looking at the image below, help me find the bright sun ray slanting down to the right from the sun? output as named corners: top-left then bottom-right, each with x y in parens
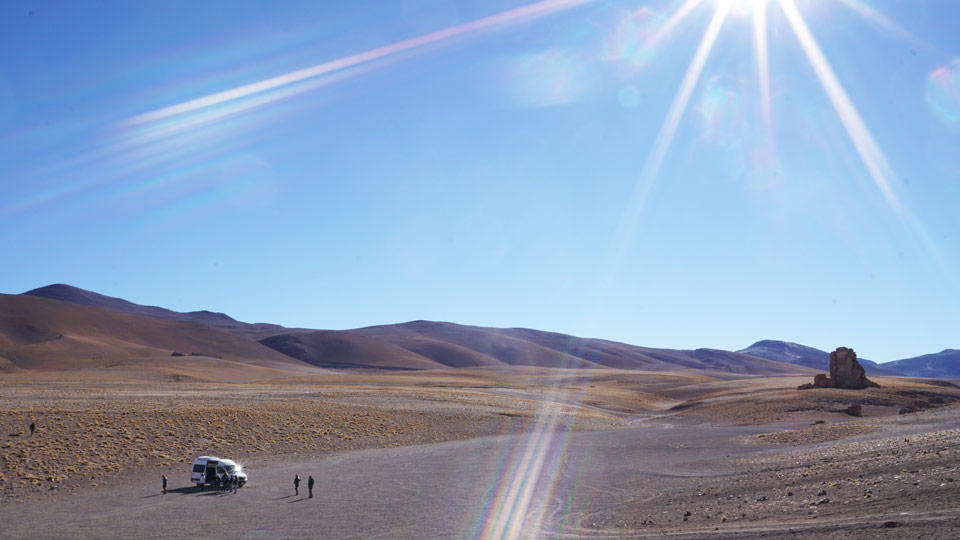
top-left (780, 0), bottom-right (903, 215)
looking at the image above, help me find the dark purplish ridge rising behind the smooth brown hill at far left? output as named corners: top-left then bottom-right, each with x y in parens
top-left (23, 284), bottom-right (299, 340)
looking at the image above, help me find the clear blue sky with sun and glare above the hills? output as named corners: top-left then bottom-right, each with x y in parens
top-left (0, 0), bottom-right (960, 361)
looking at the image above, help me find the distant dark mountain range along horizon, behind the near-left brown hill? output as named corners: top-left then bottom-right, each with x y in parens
top-left (7, 284), bottom-right (960, 378)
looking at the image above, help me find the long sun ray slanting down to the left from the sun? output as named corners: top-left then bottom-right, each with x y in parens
top-left (613, 1), bottom-right (730, 255)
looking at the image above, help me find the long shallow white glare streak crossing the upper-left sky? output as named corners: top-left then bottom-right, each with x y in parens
top-left (126, 0), bottom-right (593, 126)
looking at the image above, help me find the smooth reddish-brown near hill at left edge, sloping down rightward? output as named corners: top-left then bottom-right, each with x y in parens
top-left (0, 294), bottom-right (316, 374)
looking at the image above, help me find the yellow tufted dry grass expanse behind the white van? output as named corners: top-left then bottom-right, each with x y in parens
top-left (0, 380), bottom-right (618, 504)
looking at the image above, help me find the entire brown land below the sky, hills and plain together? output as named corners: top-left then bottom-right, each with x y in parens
top-left (0, 286), bottom-right (960, 539)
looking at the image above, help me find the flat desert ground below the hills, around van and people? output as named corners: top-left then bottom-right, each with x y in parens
top-left (0, 366), bottom-right (960, 539)
